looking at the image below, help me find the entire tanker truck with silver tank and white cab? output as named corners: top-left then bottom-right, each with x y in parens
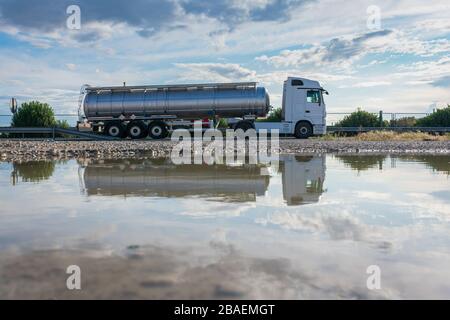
top-left (78, 77), bottom-right (328, 139)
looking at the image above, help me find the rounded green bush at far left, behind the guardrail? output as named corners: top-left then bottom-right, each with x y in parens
top-left (11, 101), bottom-right (57, 128)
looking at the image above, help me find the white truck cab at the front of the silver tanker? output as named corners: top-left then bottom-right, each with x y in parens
top-left (255, 77), bottom-right (328, 139)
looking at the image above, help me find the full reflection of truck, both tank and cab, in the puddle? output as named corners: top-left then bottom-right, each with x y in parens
top-left (80, 155), bottom-right (325, 205)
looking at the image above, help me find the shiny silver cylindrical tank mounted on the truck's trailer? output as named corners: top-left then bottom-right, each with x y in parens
top-left (83, 86), bottom-right (270, 119)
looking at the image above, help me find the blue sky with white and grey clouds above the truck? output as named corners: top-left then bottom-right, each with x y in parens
top-left (0, 0), bottom-right (450, 114)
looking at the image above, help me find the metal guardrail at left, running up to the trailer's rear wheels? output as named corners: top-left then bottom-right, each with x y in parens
top-left (0, 127), bottom-right (117, 140)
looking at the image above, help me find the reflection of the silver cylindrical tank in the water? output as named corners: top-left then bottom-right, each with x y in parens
top-left (82, 160), bottom-right (270, 202)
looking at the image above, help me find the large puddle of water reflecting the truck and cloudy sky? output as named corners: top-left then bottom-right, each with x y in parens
top-left (0, 155), bottom-right (450, 299)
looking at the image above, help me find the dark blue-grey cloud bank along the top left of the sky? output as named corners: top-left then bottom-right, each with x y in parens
top-left (0, 0), bottom-right (310, 42)
